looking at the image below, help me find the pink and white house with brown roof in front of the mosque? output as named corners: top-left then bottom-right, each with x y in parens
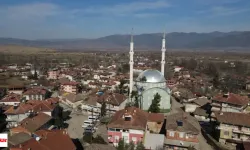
top-left (108, 107), bottom-right (164, 146)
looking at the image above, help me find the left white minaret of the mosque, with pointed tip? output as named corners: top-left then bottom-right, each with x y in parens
top-left (129, 29), bottom-right (134, 97)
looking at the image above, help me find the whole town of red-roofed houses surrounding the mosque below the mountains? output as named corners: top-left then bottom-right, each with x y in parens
top-left (0, 32), bottom-right (250, 150)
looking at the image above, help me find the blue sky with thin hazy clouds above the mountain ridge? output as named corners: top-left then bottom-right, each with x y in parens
top-left (0, 0), bottom-right (250, 39)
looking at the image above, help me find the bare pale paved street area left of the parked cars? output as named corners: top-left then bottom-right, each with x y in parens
top-left (66, 114), bottom-right (88, 139)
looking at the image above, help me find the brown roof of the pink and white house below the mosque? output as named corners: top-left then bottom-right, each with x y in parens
top-left (108, 107), bottom-right (164, 130)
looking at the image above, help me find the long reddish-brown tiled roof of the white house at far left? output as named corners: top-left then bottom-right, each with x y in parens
top-left (4, 99), bottom-right (56, 114)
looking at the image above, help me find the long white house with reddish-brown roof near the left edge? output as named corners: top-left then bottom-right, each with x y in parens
top-left (4, 98), bottom-right (59, 128)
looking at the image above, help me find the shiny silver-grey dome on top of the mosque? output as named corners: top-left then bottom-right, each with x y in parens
top-left (136, 69), bottom-right (166, 83)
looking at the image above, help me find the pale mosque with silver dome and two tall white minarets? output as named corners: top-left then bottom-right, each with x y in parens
top-left (129, 33), bottom-right (171, 112)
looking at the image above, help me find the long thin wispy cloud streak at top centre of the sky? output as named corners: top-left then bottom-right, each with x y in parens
top-left (83, 0), bottom-right (170, 15)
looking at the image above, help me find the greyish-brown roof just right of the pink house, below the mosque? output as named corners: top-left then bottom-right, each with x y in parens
top-left (166, 112), bottom-right (199, 134)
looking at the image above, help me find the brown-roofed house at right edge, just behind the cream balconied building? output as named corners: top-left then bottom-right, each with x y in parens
top-left (211, 93), bottom-right (249, 116)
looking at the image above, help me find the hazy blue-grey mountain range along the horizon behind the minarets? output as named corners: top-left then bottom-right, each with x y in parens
top-left (0, 31), bottom-right (250, 50)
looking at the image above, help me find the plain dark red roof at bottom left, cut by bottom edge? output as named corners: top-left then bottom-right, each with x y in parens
top-left (10, 130), bottom-right (76, 150)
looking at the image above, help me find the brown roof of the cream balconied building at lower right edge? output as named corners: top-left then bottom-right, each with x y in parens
top-left (214, 112), bottom-right (250, 127)
